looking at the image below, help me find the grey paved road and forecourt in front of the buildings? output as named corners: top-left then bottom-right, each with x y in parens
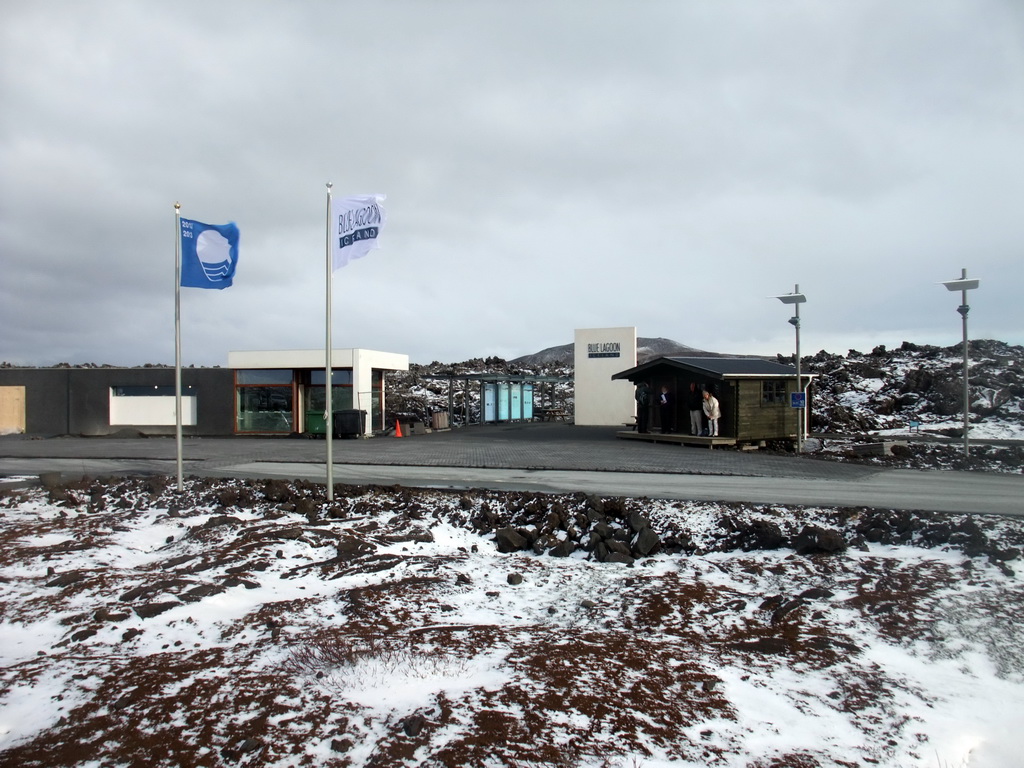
top-left (0, 423), bottom-right (1024, 516)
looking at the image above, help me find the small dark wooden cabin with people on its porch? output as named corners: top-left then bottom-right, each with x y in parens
top-left (611, 357), bottom-right (812, 447)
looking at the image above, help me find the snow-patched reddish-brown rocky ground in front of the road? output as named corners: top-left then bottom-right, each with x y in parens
top-left (0, 480), bottom-right (1024, 768)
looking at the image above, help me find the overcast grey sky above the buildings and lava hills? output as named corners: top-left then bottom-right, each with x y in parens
top-left (0, 0), bottom-right (1024, 366)
